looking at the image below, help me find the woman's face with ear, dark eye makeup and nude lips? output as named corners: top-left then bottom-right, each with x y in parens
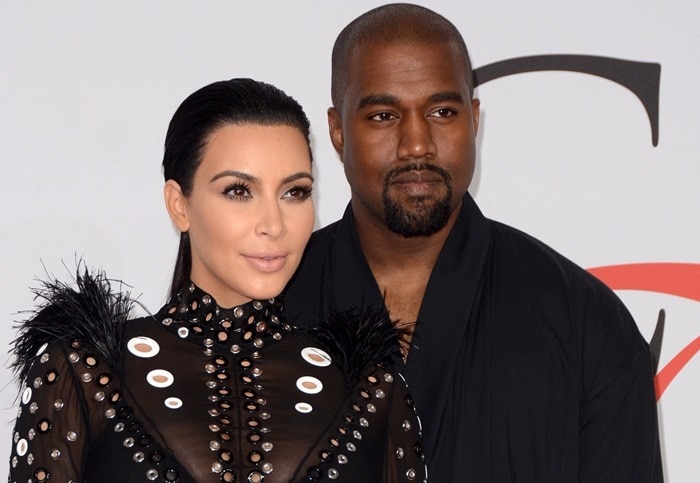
top-left (165, 124), bottom-right (314, 307)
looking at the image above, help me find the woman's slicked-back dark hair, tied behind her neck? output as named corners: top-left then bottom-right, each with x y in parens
top-left (163, 79), bottom-right (312, 297)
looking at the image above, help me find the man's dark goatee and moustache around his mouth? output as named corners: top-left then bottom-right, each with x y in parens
top-left (382, 164), bottom-right (452, 238)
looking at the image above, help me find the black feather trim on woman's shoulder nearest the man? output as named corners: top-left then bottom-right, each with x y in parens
top-left (310, 308), bottom-right (407, 388)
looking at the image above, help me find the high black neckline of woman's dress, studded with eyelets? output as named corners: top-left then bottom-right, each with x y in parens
top-left (156, 282), bottom-right (292, 354)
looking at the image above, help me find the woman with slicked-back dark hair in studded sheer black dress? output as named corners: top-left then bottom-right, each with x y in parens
top-left (10, 79), bottom-right (425, 483)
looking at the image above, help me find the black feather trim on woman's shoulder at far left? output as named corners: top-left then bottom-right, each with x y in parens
top-left (11, 264), bottom-right (134, 383)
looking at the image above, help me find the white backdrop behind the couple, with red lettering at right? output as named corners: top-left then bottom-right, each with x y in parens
top-left (0, 0), bottom-right (700, 482)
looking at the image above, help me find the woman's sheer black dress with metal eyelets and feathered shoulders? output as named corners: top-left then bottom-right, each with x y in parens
top-left (10, 276), bottom-right (426, 483)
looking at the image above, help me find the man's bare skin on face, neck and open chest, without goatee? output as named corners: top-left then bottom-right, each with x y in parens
top-left (328, 43), bottom-right (479, 334)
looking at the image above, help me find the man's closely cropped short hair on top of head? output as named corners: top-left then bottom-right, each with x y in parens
top-left (331, 3), bottom-right (474, 109)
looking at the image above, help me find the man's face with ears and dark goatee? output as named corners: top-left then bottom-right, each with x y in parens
top-left (328, 43), bottom-right (479, 237)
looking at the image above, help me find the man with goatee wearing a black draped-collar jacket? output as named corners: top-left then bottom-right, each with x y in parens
top-left (286, 4), bottom-right (663, 482)
